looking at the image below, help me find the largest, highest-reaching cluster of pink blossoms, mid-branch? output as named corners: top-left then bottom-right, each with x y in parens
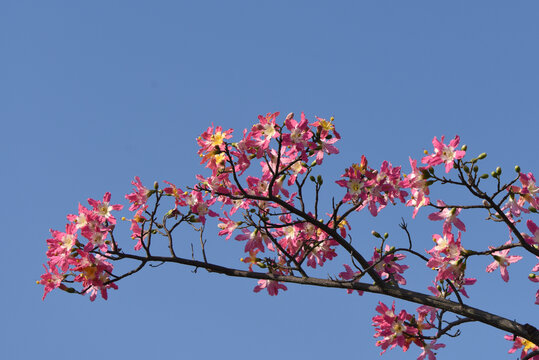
top-left (197, 113), bottom-right (346, 295)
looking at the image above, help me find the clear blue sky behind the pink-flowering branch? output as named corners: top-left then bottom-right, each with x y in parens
top-left (0, 1), bottom-right (539, 359)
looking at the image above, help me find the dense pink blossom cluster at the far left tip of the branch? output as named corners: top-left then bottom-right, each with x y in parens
top-left (38, 193), bottom-right (122, 301)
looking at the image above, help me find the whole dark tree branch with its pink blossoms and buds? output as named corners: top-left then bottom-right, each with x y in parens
top-left (39, 113), bottom-right (539, 360)
